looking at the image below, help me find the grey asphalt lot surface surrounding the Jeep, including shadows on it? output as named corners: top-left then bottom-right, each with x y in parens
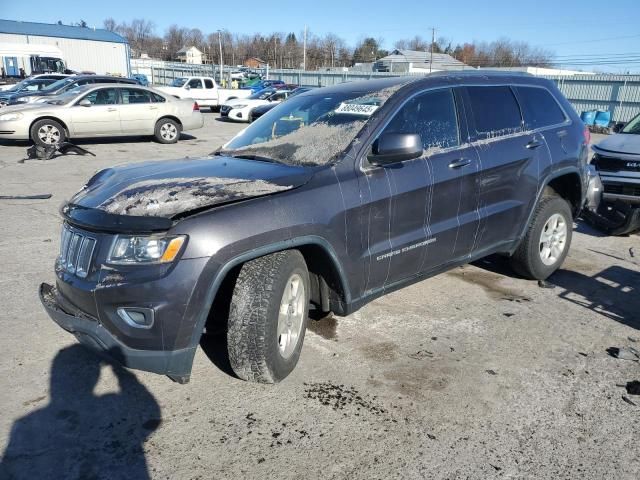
top-left (0, 118), bottom-right (640, 479)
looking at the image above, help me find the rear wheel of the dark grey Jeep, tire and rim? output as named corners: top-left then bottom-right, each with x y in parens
top-left (511, 193), bottom-right (573, 280)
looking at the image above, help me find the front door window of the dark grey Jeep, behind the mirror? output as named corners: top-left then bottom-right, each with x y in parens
top-left (384, 89), bottom-right (460, 150)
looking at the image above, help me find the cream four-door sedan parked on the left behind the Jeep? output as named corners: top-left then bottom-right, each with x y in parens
top-left (0, 83), bottom-right (204, 145)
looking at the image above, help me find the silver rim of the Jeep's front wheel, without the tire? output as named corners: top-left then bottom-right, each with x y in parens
top-left (278, 273), bottom-right (306, 359)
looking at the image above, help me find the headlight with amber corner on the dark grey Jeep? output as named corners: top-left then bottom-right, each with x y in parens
top-left (107, 235), bottom-right (187, 265)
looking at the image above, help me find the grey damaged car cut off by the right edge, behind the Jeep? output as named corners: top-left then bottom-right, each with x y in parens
top-left (587, 114), bottom-right (640, 235)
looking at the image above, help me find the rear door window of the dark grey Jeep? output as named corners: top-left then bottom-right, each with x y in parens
top-left (467, 86), bottom-right (522, 138)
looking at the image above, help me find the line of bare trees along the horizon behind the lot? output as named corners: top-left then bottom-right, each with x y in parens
top-left (104, 18), bottom-right (553, 70)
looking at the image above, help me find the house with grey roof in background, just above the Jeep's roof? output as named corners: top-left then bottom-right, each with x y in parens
top-left (373, 49), bottom-right (468, 73)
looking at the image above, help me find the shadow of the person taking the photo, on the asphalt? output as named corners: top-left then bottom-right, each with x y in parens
top-left (0, 344), bottom-right (161, 479)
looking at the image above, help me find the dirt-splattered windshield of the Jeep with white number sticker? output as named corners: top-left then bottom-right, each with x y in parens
top-left (221, 83), bottom-right (403, 166)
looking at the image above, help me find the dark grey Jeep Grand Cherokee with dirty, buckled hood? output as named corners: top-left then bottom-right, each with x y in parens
top-left (40, 72), bottom-right (600, 382)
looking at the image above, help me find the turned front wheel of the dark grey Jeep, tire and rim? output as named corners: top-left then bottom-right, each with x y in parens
top-left (227, 250), bottom-right (310, 383)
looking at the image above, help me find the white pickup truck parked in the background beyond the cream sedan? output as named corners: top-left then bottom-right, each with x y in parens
top-left (157, 77), bottom-right (253, 109)
